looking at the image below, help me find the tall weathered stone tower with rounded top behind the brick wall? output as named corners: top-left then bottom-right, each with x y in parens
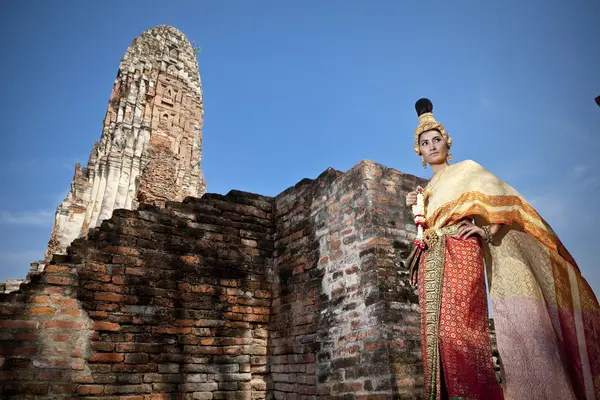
top-left (45, 25), bottom-right (206, 261)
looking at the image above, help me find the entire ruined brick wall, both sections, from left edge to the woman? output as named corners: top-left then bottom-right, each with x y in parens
top-left (0, 161), bottom-right (432, 400)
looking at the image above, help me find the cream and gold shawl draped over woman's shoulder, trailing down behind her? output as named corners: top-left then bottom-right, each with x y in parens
top-left (425, 161), bottom-right (600, 399)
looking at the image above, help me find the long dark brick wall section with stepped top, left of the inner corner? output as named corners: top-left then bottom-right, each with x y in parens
top-left (0, 192), bottom-right (273, 400)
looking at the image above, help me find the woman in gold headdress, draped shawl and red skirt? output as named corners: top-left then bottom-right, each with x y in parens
top-left (406, 99), bottom-right (600, 400)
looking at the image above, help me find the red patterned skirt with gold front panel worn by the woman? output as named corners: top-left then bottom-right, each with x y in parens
top-left (418, 235), bottom-right (503, 400)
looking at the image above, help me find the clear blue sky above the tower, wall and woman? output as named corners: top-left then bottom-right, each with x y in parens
top-left (0, 0), bottom-right (600, 293)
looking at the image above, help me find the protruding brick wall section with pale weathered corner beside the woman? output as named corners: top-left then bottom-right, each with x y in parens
top-left (269, 162), bottom-right (424, 399)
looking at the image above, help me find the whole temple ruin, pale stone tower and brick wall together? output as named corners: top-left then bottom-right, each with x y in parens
top-left (0, 26), bottom-right (502, 400)
